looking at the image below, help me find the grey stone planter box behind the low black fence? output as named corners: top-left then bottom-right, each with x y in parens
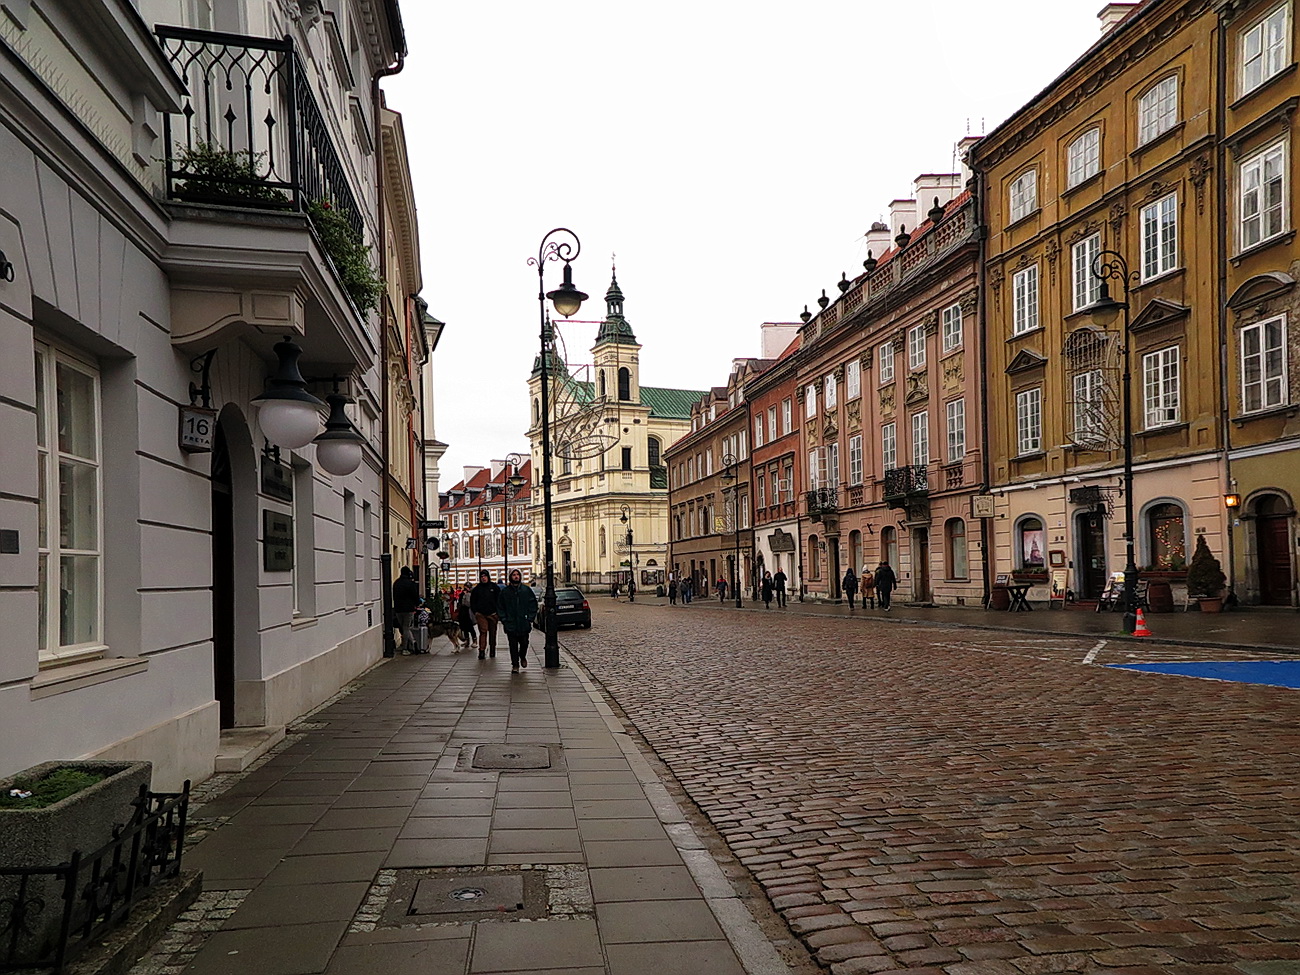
top-left (0, 761), bottom-right (152, 962)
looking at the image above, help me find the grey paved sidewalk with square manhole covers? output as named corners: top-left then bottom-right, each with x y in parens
top-left (142, 649), bottom-right (788, 975)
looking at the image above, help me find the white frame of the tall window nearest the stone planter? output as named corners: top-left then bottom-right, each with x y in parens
top-left (33, 341), bottom-right (105, 664)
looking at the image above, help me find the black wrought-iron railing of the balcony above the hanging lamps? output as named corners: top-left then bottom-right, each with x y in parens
top-left (155, 26), bottom-right (364, 234)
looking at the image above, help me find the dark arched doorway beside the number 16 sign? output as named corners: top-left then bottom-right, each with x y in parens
top-left (212, 424), bottom-right (235, 729)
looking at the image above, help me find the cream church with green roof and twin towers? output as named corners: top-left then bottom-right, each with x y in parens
top-left (528, 272), bottom-right (703, 593)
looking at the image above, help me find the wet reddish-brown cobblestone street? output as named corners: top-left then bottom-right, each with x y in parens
top-left (562, 601), bottom-right (1300, 975)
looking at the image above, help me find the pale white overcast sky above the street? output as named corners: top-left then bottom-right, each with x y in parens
top-left (384, 0), bottom-right (1102, 490)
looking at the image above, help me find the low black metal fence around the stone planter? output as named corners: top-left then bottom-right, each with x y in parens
top-left (0, 780), bottom-right (190, 972)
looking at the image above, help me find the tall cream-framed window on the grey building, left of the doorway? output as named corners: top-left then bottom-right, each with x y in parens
top-left (35, 343), bottom-right (104, 659)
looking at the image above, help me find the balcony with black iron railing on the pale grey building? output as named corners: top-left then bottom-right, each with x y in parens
top-left (155, 26), bottom-right (377, 371)
